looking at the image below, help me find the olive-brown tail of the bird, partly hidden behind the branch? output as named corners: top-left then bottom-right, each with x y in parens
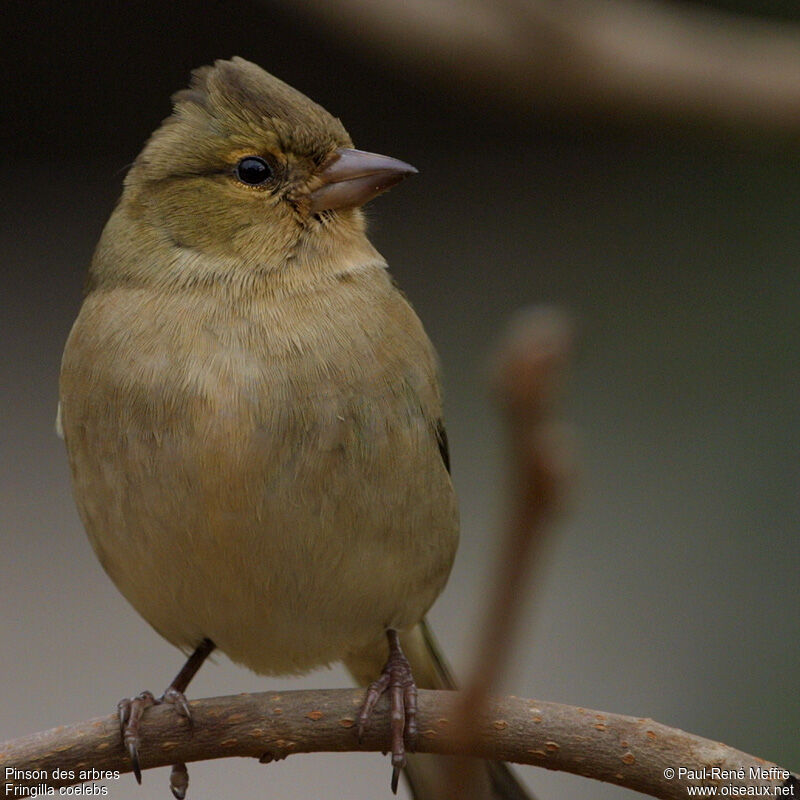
top-left (344, 620), bottom-right (532, 800)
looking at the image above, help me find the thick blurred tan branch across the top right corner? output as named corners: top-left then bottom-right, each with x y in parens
top-left (274, 0), bottom-right (800, 135)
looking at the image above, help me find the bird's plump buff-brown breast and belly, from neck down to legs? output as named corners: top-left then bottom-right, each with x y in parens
top-left (61, 275), bottom-right (457, 672)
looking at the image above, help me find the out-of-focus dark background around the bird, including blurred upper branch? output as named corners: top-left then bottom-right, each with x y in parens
top-left (0, 0), bottom-right (800, 800)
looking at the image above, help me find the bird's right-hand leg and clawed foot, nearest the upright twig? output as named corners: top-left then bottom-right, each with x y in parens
top-left (358, 628), bottom-right (417, 794)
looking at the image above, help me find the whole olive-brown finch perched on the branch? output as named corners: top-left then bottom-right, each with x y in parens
top-left (58, 57), bottom-right (528, 800)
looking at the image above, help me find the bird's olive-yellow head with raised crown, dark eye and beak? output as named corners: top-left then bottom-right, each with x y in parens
top-left (95, 58), bottom-right (416, 288)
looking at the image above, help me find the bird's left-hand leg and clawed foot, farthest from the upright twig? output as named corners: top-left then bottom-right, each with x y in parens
top-left (117, 639), bottom-right (215, 800)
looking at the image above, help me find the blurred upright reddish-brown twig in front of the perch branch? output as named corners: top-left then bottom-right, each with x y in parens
top-left (447, 308), bottom-right (573, 797)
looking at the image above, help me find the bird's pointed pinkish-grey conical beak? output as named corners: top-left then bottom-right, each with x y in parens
top-left (311, 147), bottom-right (417, 214)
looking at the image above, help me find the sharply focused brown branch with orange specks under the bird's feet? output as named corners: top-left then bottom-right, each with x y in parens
top-left (0, 689), bottom-right (797, 800)
